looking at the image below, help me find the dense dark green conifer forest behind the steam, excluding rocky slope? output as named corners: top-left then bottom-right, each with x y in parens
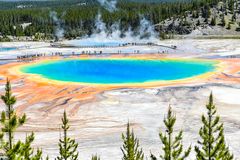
top-left (0, 0), bottom-right (223, 39)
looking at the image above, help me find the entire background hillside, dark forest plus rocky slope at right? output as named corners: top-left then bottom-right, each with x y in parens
top-left (0, 0), bottom-right (240, 41)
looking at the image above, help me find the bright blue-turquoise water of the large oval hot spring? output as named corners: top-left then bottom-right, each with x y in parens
top-left (21, 59), bottom-right (215, 84)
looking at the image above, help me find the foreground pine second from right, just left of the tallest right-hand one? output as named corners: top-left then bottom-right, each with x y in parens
top-left (151, 107), bottom-right (191, 160)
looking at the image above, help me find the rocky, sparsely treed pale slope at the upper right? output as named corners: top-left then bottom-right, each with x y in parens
top-left (157, 1), bottom-right (240, 37)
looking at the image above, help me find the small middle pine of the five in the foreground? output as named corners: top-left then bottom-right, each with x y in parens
top-left (121, 122), bottom-right (144, 160)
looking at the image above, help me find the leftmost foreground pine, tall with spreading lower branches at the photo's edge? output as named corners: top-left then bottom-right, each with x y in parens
top-left (0, 80), bottom-right (42, 160)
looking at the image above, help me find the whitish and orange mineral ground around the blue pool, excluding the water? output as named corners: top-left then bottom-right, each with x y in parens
top-left (0, 40), bottom-right (240, 160)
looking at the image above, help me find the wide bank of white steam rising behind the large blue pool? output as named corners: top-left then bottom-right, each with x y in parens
top-left (67, 13), bottom-right (159, 45)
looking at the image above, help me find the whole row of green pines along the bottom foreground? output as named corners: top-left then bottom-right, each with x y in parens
top-left (0, 80), bottom-right (234, 160)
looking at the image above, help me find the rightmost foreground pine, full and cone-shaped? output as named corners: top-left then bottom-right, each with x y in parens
top-left (195, 93), bottom-right (233, 160)
